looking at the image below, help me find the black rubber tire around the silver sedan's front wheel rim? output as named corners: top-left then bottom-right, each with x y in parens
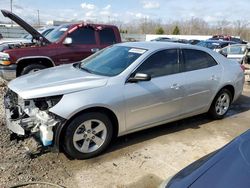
top-left (63, 112), bottom-right (113, 159)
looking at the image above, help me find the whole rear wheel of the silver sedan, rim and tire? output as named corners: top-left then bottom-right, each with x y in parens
top-left (209, 89), bottom-right (232, 119)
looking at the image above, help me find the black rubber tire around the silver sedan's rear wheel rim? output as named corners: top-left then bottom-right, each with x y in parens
top-left (208, 88), bottom-right (232, 120)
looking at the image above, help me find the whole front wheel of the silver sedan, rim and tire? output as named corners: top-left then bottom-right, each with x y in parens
top-left (63, 112), bottom-right (113, 159)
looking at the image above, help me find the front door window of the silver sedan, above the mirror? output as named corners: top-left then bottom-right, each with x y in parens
top-left (136, 49), bottom-right (179, 77)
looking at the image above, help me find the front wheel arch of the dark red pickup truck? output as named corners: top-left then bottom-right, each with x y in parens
top-left (16, 56), bottom-right (55, 77)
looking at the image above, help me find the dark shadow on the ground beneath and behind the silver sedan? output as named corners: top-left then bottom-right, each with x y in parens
top-left (106, 92), bottom-right (250, 153)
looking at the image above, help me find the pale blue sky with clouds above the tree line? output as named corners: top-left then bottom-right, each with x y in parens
top-left (0, 0), bottom-right (250, 23)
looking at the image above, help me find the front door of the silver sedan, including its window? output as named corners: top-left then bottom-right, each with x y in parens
top-left (124, 49), bottom-right (183, 130)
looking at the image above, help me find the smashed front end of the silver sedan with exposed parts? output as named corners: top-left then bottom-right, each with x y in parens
top-left (4, 90), bottom-right (65, 146)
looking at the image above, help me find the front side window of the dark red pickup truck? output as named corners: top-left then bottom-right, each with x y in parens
top-left (69, 27), bottom-right (96, 44)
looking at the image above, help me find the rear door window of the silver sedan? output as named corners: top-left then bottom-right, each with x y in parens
top-left (182, 49), bottom-right (217, 71)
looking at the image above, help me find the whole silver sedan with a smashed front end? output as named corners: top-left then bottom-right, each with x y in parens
top-left (5, 42), bottom-right (244, 159)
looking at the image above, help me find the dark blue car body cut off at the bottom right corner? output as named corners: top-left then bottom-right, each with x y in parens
top-left (161, 130), bottom-right (250, 188)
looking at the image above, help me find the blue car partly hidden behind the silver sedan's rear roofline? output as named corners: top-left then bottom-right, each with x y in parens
top-left (196, 40), bottom-right (237, 52)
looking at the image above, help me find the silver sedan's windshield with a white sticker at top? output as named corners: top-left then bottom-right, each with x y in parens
top-left (80, 46), bottom-right (146, 76)
